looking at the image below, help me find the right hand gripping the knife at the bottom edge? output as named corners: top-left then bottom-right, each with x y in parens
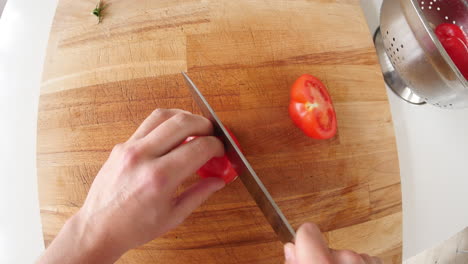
top-left (284, 223), bottom-right (382, 264)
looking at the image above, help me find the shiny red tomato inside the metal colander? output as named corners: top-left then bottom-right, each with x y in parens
top-left (435, 23), bottom-right (468, 80)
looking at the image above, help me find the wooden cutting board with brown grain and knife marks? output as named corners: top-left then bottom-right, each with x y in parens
top-left (37, 0), bottom-right (401, 263)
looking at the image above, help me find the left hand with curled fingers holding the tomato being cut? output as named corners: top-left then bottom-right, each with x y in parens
top-left (42, 109), bottom-right (225, 263)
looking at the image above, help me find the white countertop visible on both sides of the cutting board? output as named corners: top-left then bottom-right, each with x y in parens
top-left (0, 0), bottom-right (468, 263)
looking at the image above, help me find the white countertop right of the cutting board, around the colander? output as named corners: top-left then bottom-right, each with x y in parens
top-left (361, 0), bottom-right (468, 259)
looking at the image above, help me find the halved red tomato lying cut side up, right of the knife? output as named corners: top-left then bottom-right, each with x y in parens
top-left (289, 74), bottom-right (336, 139)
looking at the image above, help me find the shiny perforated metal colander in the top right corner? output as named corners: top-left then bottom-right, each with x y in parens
top-left (374, 0), bottom-right (468, 108)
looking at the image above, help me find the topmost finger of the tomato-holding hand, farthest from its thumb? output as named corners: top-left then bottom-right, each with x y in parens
top-left (130, 108), bottom-right (190, 140)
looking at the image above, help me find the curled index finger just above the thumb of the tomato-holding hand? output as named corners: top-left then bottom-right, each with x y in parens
top-left (158, 136), bottom-right (224, 191)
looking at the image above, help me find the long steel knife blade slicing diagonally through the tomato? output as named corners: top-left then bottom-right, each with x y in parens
top-left (182, 72), bottom-right (296, 243)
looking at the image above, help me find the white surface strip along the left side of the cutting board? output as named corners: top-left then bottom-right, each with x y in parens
top-left (0, 0), bottom-right (56, 263)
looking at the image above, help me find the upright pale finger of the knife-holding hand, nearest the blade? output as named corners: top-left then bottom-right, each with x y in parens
top-left (296, 223), bottom-right (332, 264)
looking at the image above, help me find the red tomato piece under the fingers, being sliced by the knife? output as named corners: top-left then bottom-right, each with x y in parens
top-left (184, 128), bottom-right (240, 184)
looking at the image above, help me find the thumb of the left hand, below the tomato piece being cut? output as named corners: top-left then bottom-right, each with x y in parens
top-left (172, 178), bottom-right (225, 228)
